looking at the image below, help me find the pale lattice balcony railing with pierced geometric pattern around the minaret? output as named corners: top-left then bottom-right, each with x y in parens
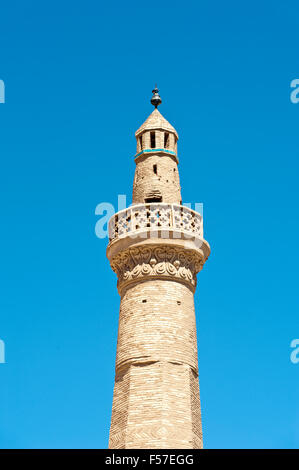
top-left (108, 203), bottom-right (203, 242)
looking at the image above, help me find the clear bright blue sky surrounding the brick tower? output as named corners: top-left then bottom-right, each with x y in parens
top-left (0, 0), bottom-right (299, 448)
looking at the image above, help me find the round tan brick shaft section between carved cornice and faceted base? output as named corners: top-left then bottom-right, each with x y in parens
top-left (116, 280), bottom-right (197, 370)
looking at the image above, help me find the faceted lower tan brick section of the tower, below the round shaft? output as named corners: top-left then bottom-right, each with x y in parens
top-left (109, 361), bottom-right (202, 449)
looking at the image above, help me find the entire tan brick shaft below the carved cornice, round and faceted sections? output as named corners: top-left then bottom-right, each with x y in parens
top-left (109, 280), bottom-right (202, 448)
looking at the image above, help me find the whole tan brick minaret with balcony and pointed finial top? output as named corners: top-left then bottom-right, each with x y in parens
top-left (107, 88), bottom-right (210, 449)
